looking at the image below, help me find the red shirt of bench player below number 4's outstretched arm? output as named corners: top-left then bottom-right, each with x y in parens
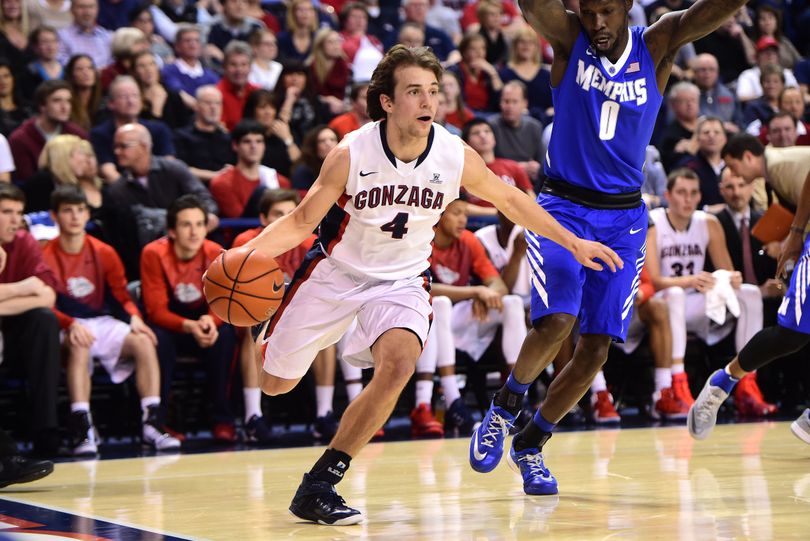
top-left (430, 230), bottom-right (500, 286)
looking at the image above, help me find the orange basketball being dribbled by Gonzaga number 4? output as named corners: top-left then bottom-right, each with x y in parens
top-left (203, 246), bottom-right (284, 327)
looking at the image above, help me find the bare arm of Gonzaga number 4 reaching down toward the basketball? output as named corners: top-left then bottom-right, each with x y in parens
top-left (245, 145), bottom-right (349, 257)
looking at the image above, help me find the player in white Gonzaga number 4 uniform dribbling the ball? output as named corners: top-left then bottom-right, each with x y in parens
top-left (234, 45), bottom-right (623, 525)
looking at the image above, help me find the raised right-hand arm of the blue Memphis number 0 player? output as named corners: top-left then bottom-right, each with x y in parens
top-left (644, 0), bottom-right (747, 66)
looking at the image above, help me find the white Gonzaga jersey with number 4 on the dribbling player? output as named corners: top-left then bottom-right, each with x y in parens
top-left (318, 122), bottom-right (464, 280)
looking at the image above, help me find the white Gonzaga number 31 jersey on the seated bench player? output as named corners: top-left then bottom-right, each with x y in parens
top-left (650, 208), bottom-right (709, 277)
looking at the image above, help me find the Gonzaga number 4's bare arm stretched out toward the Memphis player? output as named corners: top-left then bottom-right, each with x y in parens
top-left (461, 145), bottom-right (624, 272)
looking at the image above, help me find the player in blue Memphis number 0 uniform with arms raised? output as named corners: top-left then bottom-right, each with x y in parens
top-left (470, 0), bottom-right (745, 494)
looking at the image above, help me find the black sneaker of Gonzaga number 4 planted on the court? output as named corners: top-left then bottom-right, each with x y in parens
top-left (290, 473), bottom-right (364, 526)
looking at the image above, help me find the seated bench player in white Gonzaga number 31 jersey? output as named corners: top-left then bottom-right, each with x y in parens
top-left (647, 169), bottom-right (770, 413)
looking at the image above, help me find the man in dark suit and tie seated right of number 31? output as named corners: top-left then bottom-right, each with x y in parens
top-left (716, 167), bottom-right (785, 325)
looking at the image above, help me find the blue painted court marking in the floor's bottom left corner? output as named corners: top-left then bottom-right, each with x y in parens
top-left (0, 497), bottom-right (192, 541)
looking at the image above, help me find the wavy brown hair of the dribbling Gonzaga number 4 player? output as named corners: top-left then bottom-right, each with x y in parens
top-left (367, 44), bottom-right (444, 120)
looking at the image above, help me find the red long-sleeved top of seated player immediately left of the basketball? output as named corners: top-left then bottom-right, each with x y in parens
top-left (141, 237), bottom-right (223, 333)
